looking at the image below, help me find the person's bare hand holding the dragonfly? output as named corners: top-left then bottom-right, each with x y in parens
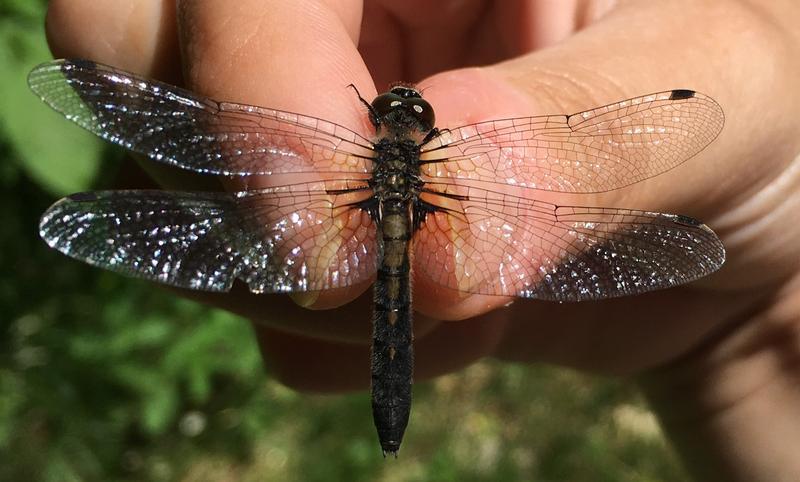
top-left (47, 0), bottom-right (800, 482)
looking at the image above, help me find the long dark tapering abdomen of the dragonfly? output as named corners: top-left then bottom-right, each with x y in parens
top-left (372, 200), bottom-right (414, 454)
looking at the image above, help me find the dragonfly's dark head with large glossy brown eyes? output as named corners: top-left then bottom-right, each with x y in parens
top-left (370, 85), bottom-right (436, 138)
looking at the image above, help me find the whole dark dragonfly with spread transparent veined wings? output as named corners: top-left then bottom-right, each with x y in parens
top-left (28, 60), bottom-right (725, 457)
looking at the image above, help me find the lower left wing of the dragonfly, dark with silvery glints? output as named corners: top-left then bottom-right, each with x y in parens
top-left (40, 186), bottom-right (376, 293)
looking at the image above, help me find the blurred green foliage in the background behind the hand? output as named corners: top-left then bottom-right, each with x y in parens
top-left (0, 0), bottom-right (685, 482)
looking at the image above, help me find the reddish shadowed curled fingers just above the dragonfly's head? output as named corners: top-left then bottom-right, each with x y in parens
top-left (359, 0), bottom-right (614, 91)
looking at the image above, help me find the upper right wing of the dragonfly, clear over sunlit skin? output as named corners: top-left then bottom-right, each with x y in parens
top-left (422, 90), bottom-right (725, 193)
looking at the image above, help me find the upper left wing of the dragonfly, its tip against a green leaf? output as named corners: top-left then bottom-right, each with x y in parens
top-left (28, 60), bottom-right (373, 179)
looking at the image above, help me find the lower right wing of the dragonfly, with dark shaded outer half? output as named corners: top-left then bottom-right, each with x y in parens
top-left (414, 186), bottom-right (725, 301)
